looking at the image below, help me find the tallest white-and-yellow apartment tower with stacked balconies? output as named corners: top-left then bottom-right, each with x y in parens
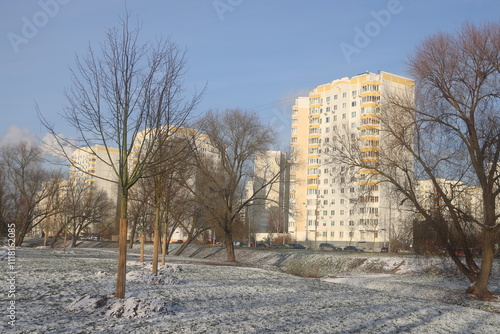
top-left (289, 72), bottom-right (414, 249)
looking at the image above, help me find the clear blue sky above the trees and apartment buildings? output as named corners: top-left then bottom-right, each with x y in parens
top-left (0, 0), bottom-right (500, 148)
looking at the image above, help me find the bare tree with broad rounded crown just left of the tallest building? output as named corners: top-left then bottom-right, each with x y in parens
top-left (198, 109), bottom-right (290, 262)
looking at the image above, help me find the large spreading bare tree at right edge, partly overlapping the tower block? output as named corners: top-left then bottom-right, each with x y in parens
top-left (334, 23), bottom-right (500, 298)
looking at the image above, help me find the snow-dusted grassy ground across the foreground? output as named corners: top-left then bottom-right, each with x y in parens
top-left (0, 248), bottom-right (500, 334)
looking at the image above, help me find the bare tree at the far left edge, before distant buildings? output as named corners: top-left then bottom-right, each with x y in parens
top-left (0, 142), bottom-right (61, 246)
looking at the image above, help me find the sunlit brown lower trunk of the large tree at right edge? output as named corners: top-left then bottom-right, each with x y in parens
top-left (467, 231), bottom-right (495, 300)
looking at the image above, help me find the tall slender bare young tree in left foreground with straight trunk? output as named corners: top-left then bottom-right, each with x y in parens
top-left (39, 13), bottom-right (201, 298)
